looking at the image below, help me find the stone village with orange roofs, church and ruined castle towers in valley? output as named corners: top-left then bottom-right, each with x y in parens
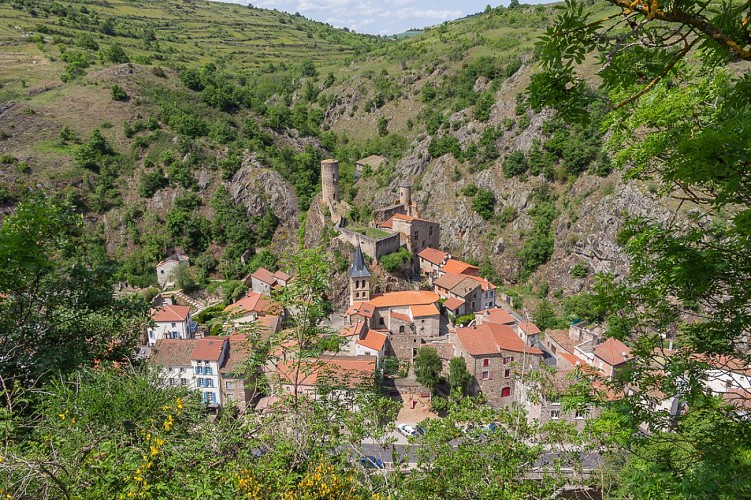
top-left (143, 160), bottom-right (751, 433)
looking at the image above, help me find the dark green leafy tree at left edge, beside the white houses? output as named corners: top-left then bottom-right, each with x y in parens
top-left (0, 195), bottom-right (146, 385)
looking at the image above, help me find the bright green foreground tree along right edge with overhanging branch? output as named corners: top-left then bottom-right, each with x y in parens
top-left (530, 0), bottom-right (751, 492)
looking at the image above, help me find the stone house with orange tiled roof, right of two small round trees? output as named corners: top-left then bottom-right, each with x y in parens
top-left (452, 323), bottom-right (542, 406)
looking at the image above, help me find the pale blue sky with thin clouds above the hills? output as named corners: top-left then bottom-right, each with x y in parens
top-left (217, 0), bottom-right (552, 35)
